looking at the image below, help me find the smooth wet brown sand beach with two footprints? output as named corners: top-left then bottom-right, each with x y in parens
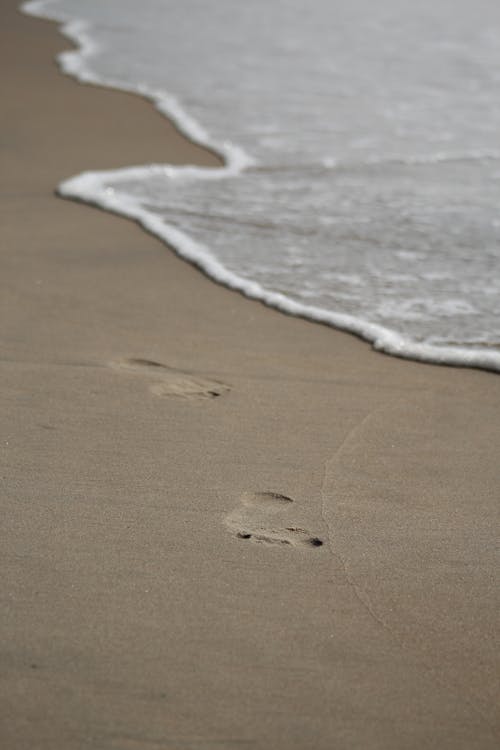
top-left (0, 0), bottom-right (500, 750)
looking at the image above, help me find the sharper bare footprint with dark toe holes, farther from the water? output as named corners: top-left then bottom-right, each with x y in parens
top-left (224, 492), bottom-right (323, 547)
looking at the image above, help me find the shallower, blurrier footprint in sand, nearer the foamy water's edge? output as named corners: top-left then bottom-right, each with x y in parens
top-left (111, 359), bottom-right (229, 400)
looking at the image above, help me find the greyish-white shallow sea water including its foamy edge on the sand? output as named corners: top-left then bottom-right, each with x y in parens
top-left (23, 0), bottom-right (500, 371)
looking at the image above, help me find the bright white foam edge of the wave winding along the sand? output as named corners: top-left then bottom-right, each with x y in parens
top-left (21, 0), bottom-right (500, 373)
